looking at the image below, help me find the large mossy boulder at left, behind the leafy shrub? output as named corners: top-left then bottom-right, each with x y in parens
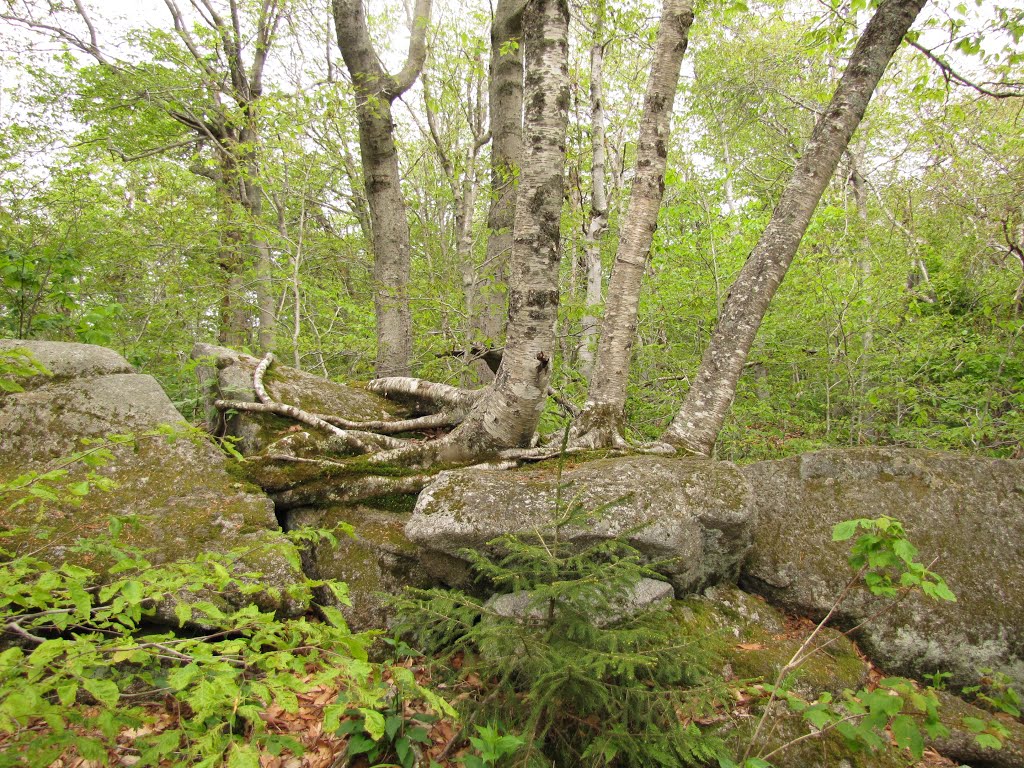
top-left (0, 341), bottom-right (308, 623)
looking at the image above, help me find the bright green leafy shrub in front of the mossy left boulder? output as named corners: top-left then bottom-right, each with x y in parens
top-left (0, 436), bottom-right (451, 767)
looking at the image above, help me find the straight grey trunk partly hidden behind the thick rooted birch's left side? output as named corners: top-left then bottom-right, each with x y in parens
top-left (472, 0), bottom-right (525, 375)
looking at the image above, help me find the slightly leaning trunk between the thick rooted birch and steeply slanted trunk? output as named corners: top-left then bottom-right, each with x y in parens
top-left (573, 0), bottom-right (693, 447)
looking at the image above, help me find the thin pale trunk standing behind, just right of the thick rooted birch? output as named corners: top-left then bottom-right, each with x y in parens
top-left (578, 0), bottom-right (608, 380)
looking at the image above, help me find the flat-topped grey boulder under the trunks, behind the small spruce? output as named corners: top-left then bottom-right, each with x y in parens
top-left (406, 457), bottom-right (752, 594)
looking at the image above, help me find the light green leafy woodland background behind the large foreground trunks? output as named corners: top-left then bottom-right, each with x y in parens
top-left (0, 0), bottom-right (1024, 460)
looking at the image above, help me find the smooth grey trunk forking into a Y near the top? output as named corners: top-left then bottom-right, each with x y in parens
top-left (333, 0), bottom-right (431, 376)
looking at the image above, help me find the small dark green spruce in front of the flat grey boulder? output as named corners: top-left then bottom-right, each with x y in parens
top-left (398, 495), bottom-right (725, 766)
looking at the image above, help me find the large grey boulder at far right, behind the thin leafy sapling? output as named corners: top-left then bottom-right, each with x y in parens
top-left (740, 449), bottom-right (1024, 685)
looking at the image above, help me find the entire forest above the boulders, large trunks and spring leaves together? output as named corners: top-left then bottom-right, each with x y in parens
top-left (0, 0), bottom-right (1024, 461)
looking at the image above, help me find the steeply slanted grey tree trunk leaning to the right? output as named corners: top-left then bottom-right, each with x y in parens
top-left (662, 0), bottom-right (926, 456)
